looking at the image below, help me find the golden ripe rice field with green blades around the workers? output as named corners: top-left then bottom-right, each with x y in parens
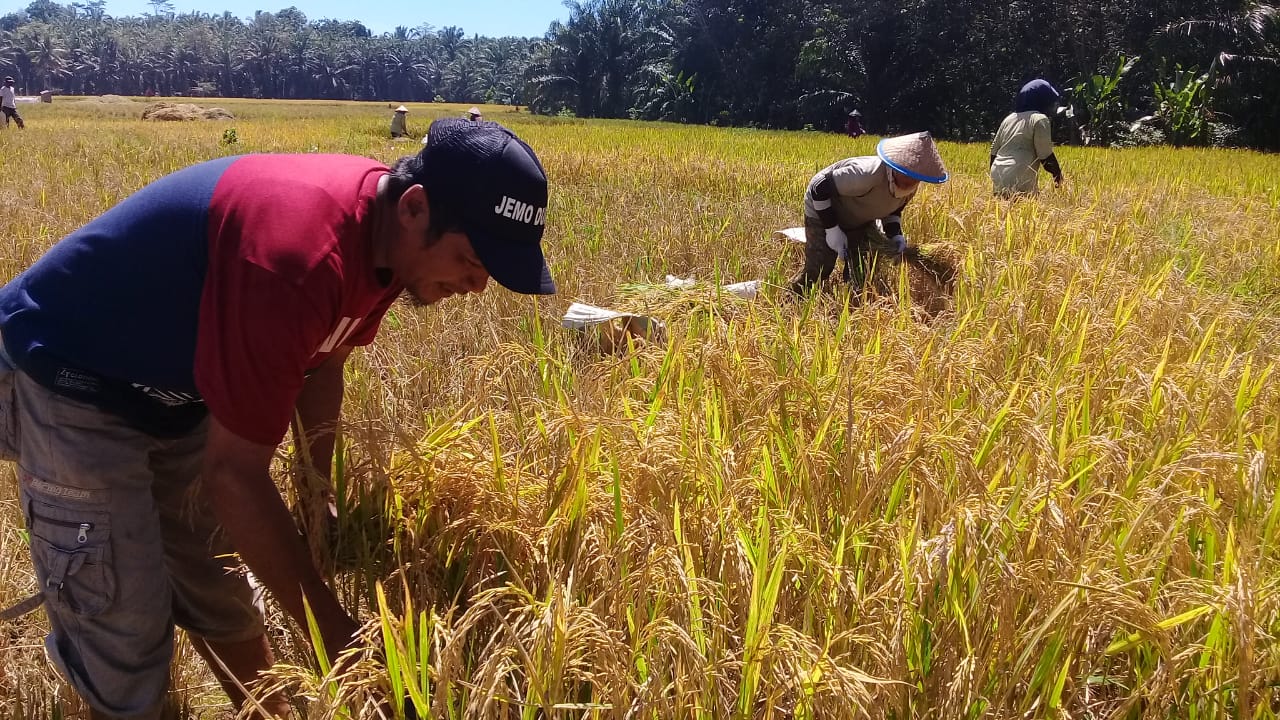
top-left (0, 97), bottom-right (1280, 720)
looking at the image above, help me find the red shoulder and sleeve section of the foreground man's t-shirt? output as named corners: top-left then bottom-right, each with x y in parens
top-left (195, 155), bottom-right (403, 445)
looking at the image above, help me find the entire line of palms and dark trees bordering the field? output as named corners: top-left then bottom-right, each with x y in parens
top-left (0, 0), bottom-right (1280, 150)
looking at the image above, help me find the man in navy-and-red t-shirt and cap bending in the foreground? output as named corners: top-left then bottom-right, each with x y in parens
top-left (0, 118), bottom-right (556, 719)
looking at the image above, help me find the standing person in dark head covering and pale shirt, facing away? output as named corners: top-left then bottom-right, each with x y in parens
top-left (989, 79), bottom-right (1062, 197)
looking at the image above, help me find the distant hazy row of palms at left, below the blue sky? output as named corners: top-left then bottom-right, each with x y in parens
top-left (0, 0), bottom-right (532, 104)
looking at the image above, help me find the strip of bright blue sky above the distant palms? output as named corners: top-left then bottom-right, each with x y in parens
top-left (87, 0), bottom-right (568, 37)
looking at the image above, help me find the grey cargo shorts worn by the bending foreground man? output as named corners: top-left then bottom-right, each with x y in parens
top-left (0, 347), bottom-right (264, 719)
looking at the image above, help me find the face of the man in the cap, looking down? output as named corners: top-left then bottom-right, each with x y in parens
top-left (390, 232), bottom-right (489, 305)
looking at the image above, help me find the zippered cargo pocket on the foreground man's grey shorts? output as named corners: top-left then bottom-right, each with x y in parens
top-left (27, 500), bottom-right (115, 616)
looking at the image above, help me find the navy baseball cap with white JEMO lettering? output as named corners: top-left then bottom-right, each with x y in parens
top-left (422, 118), bottom-right (556, 295)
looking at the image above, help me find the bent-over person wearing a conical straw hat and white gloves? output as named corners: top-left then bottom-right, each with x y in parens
top-left (791, 132), bottom-right (948, 293)
